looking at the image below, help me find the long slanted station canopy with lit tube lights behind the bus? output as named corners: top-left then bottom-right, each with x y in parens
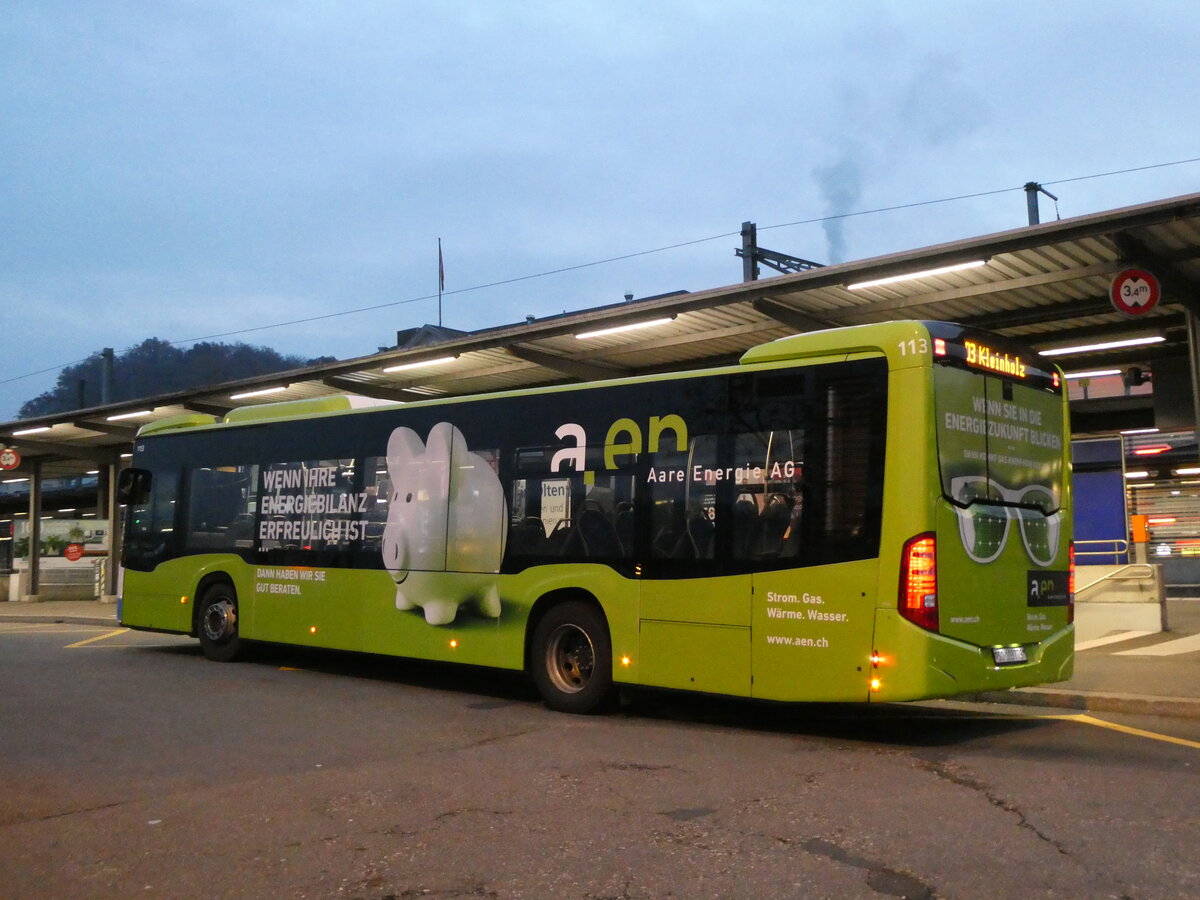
top-left (0, 193), bottom-right (1200, 476)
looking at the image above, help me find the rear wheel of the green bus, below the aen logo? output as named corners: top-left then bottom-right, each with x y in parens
top-left (529, 600), bottom-right (612, 714)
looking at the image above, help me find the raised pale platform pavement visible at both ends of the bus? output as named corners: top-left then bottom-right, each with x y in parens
top-left (0, 599), bottom-right (1200, 719)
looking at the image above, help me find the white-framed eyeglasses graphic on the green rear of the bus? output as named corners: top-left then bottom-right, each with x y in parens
top-left (950, 475), bottom-right (1062, 568)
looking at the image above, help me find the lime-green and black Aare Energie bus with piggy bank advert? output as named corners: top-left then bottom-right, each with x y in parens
top-left (119, 322), bottom-right (1074, 713)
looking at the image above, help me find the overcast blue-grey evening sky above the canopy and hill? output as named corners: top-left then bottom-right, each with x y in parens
top-left (0, 0), bottom-right (1200, 420)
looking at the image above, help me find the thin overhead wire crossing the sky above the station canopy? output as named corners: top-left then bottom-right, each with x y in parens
top-left (7, 156), bottom-right (1200, 393)
